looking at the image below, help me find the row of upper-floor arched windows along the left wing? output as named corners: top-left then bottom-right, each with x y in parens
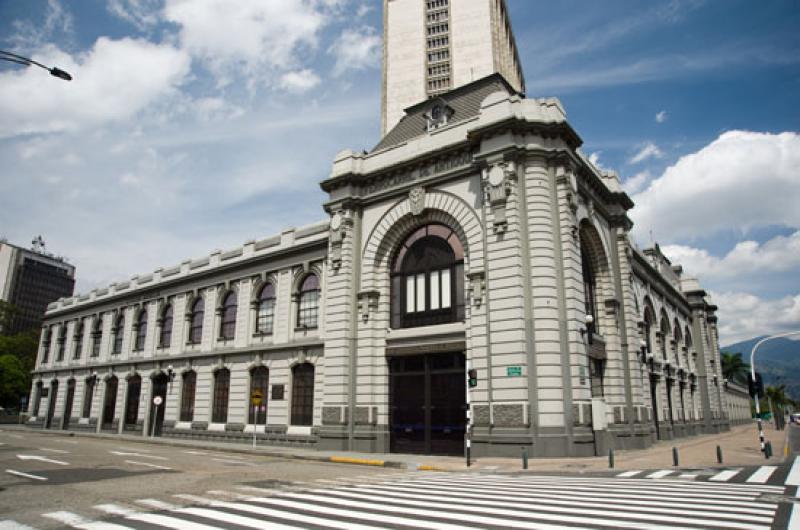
top-left (42, 273), bottom-right (320, 364)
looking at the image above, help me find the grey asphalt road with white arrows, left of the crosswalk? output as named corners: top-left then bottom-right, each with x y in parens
top-left (0, 429), bottom-right (400, 529)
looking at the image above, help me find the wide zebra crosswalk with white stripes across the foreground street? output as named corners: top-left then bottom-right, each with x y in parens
top-left (0, 472), bottom-right (786, 530)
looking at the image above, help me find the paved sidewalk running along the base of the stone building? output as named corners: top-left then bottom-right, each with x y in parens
top-left (2, 421), bottom-right (796, 473)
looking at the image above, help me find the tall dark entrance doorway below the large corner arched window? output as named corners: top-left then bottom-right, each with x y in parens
top-left (389, 353), bottom-right (466, 455)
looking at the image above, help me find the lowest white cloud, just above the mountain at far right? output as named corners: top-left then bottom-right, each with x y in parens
top-left (710, 292), bottom-right (800, 345)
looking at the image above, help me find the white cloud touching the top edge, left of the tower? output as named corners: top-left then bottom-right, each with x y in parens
top-left (164, 0), bottom-right (326, 85)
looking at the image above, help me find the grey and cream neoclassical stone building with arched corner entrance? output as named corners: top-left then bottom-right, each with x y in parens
top-left (31, 74), bottom-right (742, 456)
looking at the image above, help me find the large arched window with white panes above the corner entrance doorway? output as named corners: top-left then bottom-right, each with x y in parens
top-left (391, 224), bottom-right (464, 328)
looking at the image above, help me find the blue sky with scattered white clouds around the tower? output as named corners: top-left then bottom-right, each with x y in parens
top-left (0, 0), bottom-right (800, 344)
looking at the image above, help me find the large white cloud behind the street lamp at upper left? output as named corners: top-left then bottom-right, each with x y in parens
top-left (0, 37), bottom-right (190, 138)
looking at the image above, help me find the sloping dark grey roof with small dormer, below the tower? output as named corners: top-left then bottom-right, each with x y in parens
top-left (372, 73), bottom-right (516, 152)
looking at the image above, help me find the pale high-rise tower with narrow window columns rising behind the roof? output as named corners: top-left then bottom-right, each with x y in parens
top-left (381, 0), bottom-right (525, 135)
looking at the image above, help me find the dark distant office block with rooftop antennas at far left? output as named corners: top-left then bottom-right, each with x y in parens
top-left (0, 241), bottom-right (75, 335)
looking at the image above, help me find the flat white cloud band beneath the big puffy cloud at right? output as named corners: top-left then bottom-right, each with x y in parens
top-left (662, 231), bottom-right (800, 280)
